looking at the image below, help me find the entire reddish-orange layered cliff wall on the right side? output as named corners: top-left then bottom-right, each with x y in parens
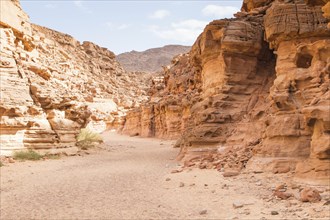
top-left (123, 0), bottom-right (330, 184)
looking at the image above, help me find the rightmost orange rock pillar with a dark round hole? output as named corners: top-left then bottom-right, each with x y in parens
top-left (257, 1), bottom-right (330, 182)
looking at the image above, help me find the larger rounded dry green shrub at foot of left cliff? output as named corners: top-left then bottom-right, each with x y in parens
top-left (77, 128), bottom-right (103, 150)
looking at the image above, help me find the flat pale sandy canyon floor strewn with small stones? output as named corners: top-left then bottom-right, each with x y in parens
top-left (0, 132), bottom-right (330, 220)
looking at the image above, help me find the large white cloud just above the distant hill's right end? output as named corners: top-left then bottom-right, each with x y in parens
top-left (149, 19), bottom-right (208, 44)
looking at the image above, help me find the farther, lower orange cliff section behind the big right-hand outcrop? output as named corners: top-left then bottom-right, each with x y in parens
top-left (123, 52), bottom-right (201, 139)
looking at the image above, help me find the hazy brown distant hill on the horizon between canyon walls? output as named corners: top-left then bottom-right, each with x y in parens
top-left (116, 45), bottom-right (191, 72)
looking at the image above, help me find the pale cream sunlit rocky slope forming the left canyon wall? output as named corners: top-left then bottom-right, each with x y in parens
top-left (0, 1), bottom-right (147, 155)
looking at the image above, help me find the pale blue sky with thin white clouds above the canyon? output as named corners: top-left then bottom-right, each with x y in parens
top-left (21, 0), bottom-right (242, 54)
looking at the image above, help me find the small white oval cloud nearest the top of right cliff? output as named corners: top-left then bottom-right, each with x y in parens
top-left (202, 5), bottom-right (239, 19)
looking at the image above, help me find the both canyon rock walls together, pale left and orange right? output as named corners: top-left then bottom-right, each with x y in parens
top-left (0, 0), bottom-right (330, 189)
